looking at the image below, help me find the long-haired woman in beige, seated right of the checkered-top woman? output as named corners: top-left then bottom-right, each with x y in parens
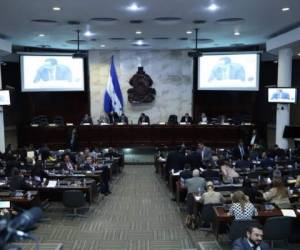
top-left (263, 179), bottom-right (291, 208)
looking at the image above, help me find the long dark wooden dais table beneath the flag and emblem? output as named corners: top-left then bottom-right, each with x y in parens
top-left (18, 125), bottom-right (252, 148)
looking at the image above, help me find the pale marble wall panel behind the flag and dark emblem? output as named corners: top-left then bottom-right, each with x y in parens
top-left (89, 50), bottom-right (193, 123)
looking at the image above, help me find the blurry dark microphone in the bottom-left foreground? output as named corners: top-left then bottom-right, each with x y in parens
top-left (7, 207), bottom-right (42, 232)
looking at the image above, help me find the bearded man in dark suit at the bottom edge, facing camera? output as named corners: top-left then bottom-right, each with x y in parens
top-left (232, 225), bottom-right (270, 250)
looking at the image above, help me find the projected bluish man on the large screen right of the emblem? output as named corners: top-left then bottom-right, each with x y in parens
top-left (208, 57), bottom-right (245, 81)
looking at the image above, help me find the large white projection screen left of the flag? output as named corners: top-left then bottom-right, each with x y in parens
top-left (21, 54), bottom-right (84, 92)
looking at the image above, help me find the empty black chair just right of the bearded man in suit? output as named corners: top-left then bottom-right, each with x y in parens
top-left (264, 217), bottom-right (292, 248)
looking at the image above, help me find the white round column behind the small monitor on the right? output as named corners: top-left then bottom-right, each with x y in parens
top-left (275, 48), bottom-right (293, 149)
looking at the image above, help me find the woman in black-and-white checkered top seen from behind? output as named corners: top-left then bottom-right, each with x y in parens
top-left (229, 191), bottom-right (257, 220)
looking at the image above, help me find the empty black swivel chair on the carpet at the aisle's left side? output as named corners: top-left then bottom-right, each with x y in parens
top-left (62, 190), bottom-right (88, 218)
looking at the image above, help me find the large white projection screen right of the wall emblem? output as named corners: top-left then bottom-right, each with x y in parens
top-left (198, 53), bottom-right (260, 91)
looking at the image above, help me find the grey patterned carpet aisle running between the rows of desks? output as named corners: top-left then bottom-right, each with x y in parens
top-left (27, 165), bottom-right (194, 250)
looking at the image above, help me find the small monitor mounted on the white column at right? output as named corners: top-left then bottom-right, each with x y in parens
top-left (268, 88), bottom-right (297, 103)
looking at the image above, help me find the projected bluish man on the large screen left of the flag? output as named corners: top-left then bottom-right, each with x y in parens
top-left (33, 58), bottom-right (72, 82)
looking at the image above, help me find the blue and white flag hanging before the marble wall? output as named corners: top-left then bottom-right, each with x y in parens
top-left (104, 56), bottom-right (123, 115)
